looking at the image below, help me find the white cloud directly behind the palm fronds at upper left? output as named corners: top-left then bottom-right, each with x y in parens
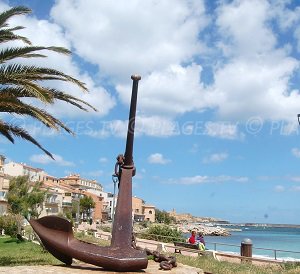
top-left (0, 2), bottom-right (116, 117)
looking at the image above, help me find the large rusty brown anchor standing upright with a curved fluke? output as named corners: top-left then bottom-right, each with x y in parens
top-left (29, 75), bottom-right (148, 271)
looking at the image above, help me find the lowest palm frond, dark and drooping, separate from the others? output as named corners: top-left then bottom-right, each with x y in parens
top-left (0, 120), bottom-right (54, 160)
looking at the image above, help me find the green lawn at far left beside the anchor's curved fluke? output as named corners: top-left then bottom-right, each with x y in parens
top-left (0, 236), bottom-right (62, 266)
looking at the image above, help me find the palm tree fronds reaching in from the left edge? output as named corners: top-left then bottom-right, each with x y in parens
top-left (0, 6), bottom-right (96, 158)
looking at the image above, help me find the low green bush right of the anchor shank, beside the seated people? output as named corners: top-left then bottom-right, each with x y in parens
top-left (139, 225), bottom-right (185, 243)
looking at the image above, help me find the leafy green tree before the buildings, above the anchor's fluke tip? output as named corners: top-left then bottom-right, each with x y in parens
top-left (6, 176), bottom-right (46, 237)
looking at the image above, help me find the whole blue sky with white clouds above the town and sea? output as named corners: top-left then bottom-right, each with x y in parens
top-left (0, 0), bottom-right (300, 224)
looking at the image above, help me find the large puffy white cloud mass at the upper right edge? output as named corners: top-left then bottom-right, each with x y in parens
top-left (213, 0), bottom-right (300, 121)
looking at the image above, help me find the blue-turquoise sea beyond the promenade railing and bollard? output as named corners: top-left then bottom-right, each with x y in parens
top-left (186, 226), bottom-right (300, 261)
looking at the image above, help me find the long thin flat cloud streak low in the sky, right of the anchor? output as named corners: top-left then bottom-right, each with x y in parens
top-left (164, 175), bottom-right (249, 185)
